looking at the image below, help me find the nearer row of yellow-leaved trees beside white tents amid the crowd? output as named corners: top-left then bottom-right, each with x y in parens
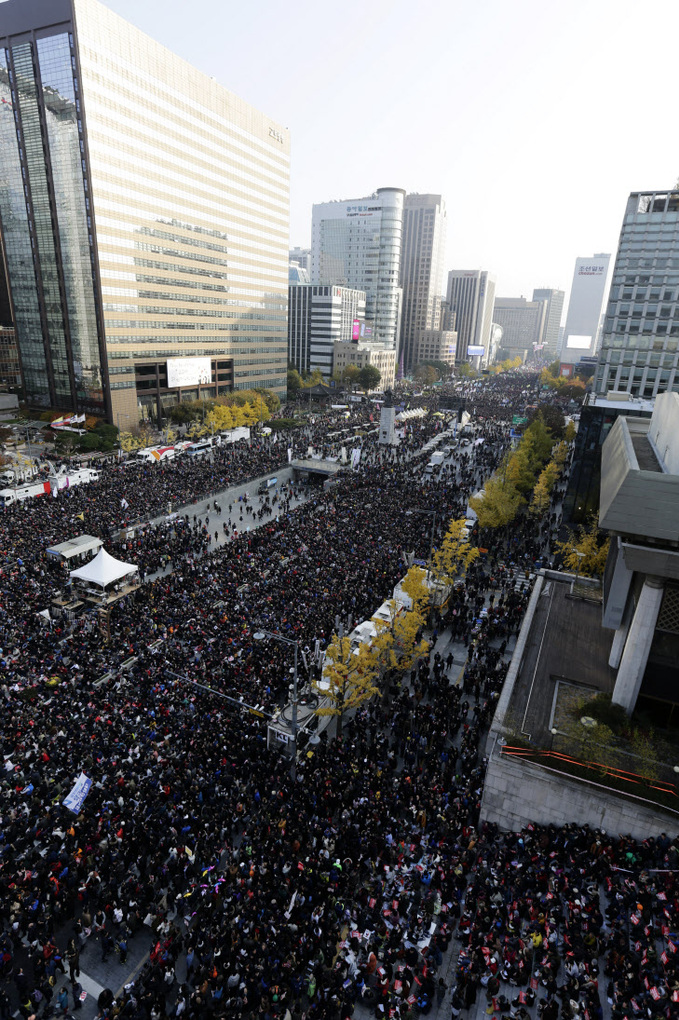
top-left (316, 519), bottom-right (479, 736)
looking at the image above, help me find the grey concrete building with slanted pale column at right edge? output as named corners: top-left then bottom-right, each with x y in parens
top-left (599, 385), bottom-right (679, 725)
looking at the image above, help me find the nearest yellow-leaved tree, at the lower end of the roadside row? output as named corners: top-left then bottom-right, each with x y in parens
top-left (314, 633), bottom-right (381, 736)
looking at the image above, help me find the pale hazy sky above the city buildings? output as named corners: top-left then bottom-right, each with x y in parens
top-left (105, 0), bottom-right (679, 306)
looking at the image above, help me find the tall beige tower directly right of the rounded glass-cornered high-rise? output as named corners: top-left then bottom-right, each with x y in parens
top-left (399, 195), bottom-right (448, 371)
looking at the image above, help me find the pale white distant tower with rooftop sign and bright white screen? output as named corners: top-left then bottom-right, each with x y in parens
top-left (559, 253), bottom-right (611, 365)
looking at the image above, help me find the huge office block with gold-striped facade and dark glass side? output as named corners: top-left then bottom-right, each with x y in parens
top-left (0, 0), bottom-right (290, 424)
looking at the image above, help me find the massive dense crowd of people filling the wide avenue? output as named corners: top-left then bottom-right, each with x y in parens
top-left (0, 374), bottom-right (679, 1020)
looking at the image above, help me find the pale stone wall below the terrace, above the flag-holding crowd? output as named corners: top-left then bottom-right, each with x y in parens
top-left (481, 750), bottom-right (679, 839)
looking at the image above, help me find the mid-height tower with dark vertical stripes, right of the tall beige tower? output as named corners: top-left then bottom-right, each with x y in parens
top-left (443, 269), bottom-right (495, 363)
